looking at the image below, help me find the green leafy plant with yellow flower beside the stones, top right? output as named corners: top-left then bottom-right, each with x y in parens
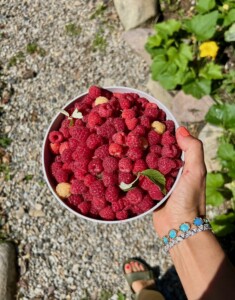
top-left (145, 0), bottom-right (235, 98)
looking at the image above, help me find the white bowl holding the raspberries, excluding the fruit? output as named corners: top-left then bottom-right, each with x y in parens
top-left (42, 86), bottom-right (182, 224)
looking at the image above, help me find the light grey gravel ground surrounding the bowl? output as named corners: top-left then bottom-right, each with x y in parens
top-left (0, 0), bottom-right (184, 299)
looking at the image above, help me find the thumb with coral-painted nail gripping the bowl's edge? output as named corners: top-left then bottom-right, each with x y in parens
top-left (176, 126), bottom-right (206, 173)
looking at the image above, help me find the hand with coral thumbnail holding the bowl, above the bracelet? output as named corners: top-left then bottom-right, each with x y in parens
top-left (153, 127), bottom-right (206, 237)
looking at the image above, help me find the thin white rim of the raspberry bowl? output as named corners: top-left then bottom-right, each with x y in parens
top-left (41, 86), bottom-right (184, 224)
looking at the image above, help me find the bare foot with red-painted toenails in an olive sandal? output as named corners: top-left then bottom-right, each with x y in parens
top-left (125, 261), bottom-right (155, 294)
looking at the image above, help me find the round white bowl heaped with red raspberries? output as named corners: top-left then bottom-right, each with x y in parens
top-left (42, 86), bottom-right (183, 223)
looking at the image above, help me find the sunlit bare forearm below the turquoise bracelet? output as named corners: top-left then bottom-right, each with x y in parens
top-left (170, 231), bottom-right (235, 300)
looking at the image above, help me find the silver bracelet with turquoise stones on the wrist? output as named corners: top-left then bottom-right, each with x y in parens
top-left (162, 217), bottom-right (212, 253)
